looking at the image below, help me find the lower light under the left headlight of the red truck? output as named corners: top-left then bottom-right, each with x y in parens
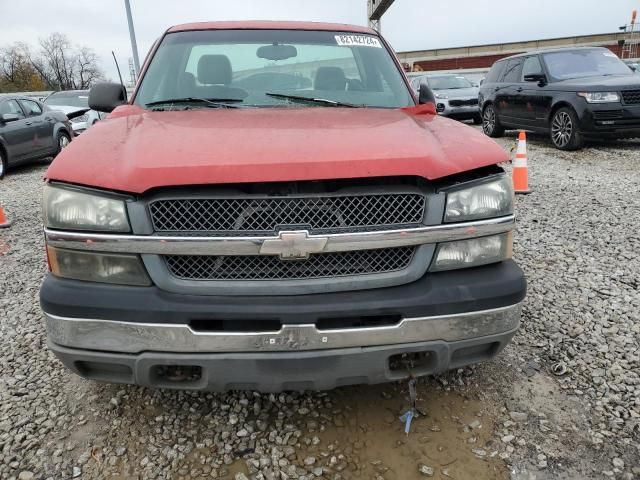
top-left (47, 246), bottom-right (151, 286)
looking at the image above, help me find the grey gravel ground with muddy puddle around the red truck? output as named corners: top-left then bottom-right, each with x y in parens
top-left (0, 133), bottom-right (640, 480)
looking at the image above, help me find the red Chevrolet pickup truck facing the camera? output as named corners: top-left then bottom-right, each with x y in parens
top-left (40, 22), bottom-right (526, 391)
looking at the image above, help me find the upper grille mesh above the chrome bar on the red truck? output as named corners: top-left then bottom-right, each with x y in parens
top-left (149, 193), bottom-right (426, 235)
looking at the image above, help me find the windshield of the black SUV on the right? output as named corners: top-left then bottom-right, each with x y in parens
top-left (542, 48), bottom-right (633, 80)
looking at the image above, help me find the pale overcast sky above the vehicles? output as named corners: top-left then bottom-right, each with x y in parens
top-left (0, 0), bottom-right (640, 81)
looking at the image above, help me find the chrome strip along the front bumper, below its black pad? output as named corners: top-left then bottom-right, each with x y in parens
top-left (45, 303), bottom-right (521, 354)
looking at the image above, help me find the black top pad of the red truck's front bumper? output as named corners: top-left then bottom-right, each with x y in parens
top-left (40, 260), bottom-right (526, 324)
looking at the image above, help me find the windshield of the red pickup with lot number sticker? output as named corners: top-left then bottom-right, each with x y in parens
top-left (135, 30), bottom-right (414, 108)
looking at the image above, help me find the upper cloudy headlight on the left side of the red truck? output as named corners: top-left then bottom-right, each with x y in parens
top-left (43, 185), bottom-right (130, 232)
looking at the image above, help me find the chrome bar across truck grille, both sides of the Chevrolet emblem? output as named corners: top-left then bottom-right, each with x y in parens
top-left (45, 215), bottom-right (515, 255)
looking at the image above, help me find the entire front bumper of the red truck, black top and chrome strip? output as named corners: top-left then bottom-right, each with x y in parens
top-left (41, 261), bottom-right (526, 391)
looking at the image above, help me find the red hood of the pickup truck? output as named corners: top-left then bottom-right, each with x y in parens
top-left (47, 105), bottom-right (509, 194)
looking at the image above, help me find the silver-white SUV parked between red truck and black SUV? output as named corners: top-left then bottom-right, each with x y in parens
top-left (411, 74), bottom-right (482, 124)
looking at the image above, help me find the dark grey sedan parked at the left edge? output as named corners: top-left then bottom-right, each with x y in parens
top-left (0, 94), bottom-right (73, 178)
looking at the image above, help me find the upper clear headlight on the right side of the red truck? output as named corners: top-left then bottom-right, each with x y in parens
top-left (444, 175), bottom-right (513, 222)
